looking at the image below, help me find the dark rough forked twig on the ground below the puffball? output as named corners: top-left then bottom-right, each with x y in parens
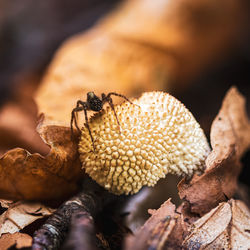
top-left (32, 181), bottom-right (114, 250)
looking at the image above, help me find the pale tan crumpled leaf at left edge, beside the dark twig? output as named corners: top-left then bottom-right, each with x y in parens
top-left (0, 202), bottom-right (54, 236)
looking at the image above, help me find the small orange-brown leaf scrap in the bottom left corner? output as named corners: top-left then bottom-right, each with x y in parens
top-left (0, 233), bottom-right (32, 250)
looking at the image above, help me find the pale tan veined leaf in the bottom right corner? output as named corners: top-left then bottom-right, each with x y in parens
top-left (183, 199), bottom-right (250, 250)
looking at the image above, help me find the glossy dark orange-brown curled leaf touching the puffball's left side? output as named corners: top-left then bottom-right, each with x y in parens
top-left (0, 121), bottom-right (84, 201)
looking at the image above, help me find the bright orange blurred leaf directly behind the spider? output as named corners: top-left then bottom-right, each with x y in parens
top-left (36, 29), bottom-right (172, 129)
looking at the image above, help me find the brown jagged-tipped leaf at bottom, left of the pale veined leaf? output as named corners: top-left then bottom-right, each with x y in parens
top-left (125, 199), bottom-right (187, 250)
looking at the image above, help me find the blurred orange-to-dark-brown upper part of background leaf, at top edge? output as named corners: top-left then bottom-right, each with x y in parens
top-left (99, 0), bottom-right (248, 84)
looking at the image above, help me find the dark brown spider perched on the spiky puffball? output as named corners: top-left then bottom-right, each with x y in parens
top-left (70, 92), bottom-right (136, 150)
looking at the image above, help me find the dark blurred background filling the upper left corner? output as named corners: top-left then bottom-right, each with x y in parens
top-left (0, 0), bottom-right (118, 103)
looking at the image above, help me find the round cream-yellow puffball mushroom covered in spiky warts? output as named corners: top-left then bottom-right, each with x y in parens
top-left (79, 92), bottom-right (210, 194)
